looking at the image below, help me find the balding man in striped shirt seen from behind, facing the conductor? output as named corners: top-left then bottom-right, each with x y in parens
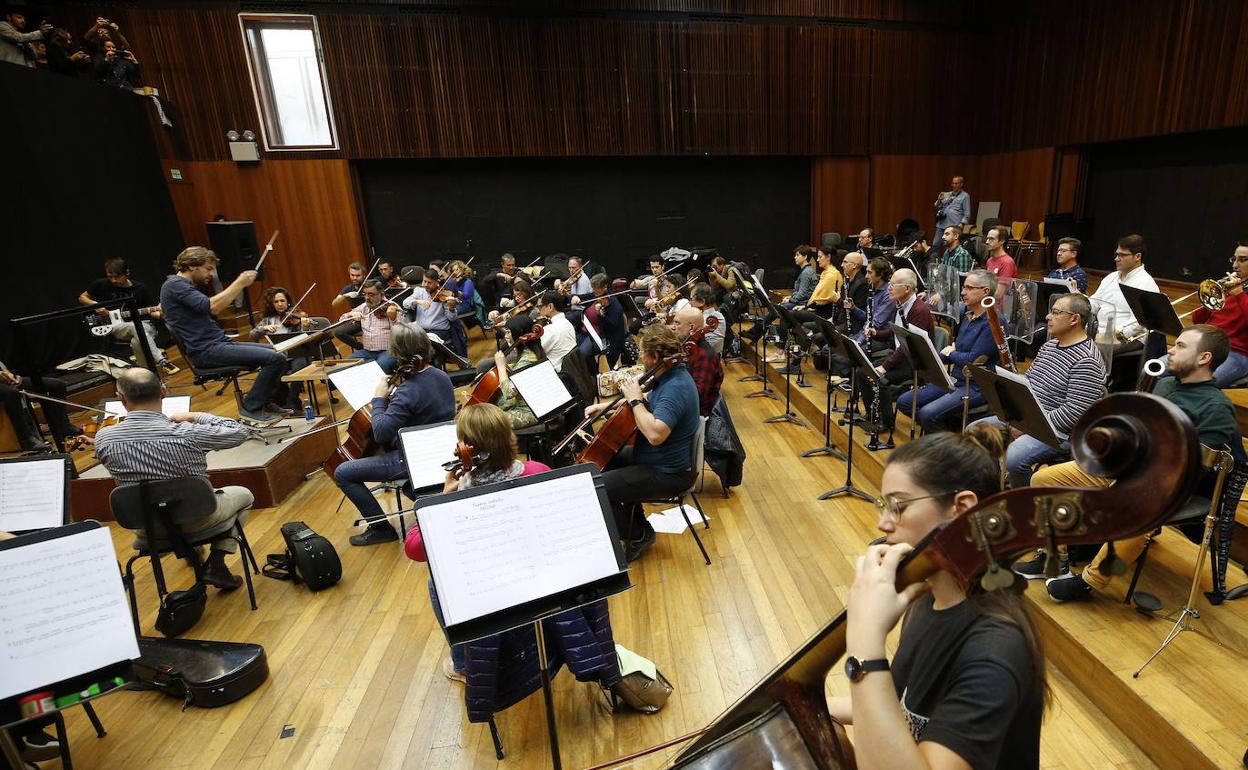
top-left (95, 367), bottom-right (256, 590)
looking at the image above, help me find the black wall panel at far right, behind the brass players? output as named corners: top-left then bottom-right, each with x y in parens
top-left (1083, 129), bottom-right (1248, 281)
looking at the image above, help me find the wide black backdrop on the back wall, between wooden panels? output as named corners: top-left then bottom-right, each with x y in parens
top-left (358, 157), bottom-right (810, 276)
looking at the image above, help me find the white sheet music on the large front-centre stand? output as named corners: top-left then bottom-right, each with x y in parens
top-left (417, 473), bottom-right (619, 625)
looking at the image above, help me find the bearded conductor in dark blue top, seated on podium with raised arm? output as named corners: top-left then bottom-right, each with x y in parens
top-left (160, 246), bottom-right (291, 423)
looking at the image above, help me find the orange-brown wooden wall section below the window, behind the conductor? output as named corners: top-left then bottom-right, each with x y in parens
top-left (166, 160), bottom-right (371, 314)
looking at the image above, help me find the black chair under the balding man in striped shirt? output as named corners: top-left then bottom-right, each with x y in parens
top-left (109, 475), bottom-right (260, 630)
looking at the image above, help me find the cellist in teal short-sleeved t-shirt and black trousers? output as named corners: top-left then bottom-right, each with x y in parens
top-left (585, 323), bottom-right (700, 562)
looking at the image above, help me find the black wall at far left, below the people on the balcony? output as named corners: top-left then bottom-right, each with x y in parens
top-left (0, 65), bottom-right (183, 372)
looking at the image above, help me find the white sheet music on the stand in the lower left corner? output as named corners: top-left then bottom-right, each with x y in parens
top-left (0, 527), bottom-right (139, 698)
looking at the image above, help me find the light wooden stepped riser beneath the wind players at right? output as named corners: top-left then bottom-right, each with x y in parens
top-left (725, 343), bottom-right (1248, 768)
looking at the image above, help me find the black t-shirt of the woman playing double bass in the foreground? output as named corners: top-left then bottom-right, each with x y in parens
top-left (891, 595), bottom-right (1043, 770)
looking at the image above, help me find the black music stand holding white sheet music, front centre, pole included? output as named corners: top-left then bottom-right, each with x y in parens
top-left (416, 463), bottom-right (631, 770)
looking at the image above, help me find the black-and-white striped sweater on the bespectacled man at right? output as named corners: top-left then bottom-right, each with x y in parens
top-left (1027, 338), bottom-right (1106, 438)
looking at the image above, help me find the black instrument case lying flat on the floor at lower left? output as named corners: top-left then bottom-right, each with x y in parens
top-left (135, 636), bottom-right (268, 709)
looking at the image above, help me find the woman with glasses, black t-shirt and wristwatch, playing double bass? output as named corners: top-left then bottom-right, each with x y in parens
top-left (827, 429), bottom-right (1047, 769)
